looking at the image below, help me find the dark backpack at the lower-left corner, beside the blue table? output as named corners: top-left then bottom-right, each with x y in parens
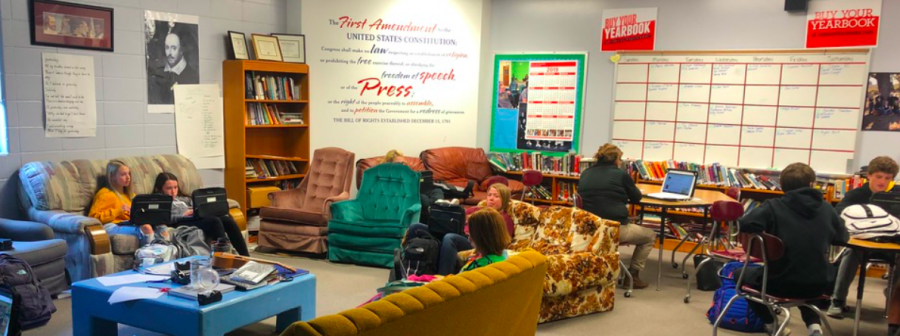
top-left (0, 254), bottom-right (56, 335)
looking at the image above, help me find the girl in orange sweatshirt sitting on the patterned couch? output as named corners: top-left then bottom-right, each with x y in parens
top-left (88, 160), bottom-right (169, 245)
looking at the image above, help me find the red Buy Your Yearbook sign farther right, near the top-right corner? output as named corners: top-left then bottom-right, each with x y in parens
top-left (806, 0), bottom-right (881, 48)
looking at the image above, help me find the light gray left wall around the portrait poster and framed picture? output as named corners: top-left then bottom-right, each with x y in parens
top-left (0, 0), bottom-right (287, 218)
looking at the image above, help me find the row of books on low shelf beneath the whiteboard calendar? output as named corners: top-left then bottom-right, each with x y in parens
top-left (626, 160), bottom-right (781, 190)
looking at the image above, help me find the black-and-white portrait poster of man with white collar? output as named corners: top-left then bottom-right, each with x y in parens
top-left (144, 11), bottom-right (200, 113)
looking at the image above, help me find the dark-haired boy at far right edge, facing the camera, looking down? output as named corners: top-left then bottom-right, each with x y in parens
top-left (826, 156), bottom-right (900, 323)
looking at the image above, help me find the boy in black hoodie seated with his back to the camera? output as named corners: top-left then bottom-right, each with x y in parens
top-left (740, 162), bottom-right (849, 335)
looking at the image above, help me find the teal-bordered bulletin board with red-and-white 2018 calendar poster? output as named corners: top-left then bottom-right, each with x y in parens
top-left (491, 52), bottom-right (587, 153)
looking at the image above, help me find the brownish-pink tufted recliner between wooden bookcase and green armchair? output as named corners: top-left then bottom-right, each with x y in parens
top-left (259, 147), bottom-right (356, 253)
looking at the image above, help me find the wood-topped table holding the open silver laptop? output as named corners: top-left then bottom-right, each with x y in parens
top-left (637, 183), bottom-right (737, 290)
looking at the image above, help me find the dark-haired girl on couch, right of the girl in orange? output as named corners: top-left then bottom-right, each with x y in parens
top-left (153, 172), bottom-right (250, 256)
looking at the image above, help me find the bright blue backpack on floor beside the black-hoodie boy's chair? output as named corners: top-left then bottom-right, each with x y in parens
top-left (706, 261), bottom-right (765, 333)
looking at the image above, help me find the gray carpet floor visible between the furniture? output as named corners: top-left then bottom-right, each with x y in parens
top-left (25, 248), bottom-right (887, 336)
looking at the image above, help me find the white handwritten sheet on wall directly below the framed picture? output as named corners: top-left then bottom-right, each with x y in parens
top-left (42, 53), bottom-right (97, 138)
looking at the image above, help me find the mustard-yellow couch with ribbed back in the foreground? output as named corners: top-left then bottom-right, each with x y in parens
top-left (281, 251), bottom-right (547, 336)
